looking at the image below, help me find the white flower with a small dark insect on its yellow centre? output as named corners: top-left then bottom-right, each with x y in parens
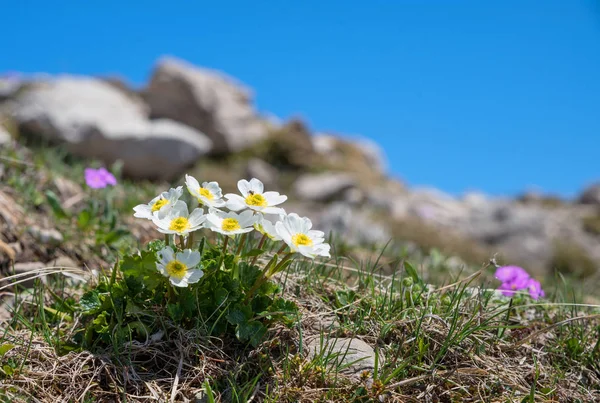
top-left (225, 178), bottom-right (287, 214)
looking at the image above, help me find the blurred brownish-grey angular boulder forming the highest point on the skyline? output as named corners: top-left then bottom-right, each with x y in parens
top-left (144, 58), bottom-right (267, 153)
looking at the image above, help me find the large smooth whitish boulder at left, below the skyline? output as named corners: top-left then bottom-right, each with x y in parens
top-left (13, 76), bottom-right (211, 179)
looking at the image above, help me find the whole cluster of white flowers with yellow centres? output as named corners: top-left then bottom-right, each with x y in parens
top-left (133, 175), bottom-right (330, 287)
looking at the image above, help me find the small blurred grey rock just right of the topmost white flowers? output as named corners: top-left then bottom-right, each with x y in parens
top-left (294, 172), bottom-right (356, 202)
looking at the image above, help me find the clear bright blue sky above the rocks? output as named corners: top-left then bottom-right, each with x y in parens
top-left (0, 0), bottom-right (600, 196)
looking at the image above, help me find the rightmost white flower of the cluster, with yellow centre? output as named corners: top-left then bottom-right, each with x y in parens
top-left (275, 213), bottom-right (331, 259)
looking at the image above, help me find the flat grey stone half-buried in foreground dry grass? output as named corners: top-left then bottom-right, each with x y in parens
top-left (306, 337), bottom-right (382, 377)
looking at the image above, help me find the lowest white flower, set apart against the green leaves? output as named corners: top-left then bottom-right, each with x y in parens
top-left (156, 246), bottom-right (204, 287)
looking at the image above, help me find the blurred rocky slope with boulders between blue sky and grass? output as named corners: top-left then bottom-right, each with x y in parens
top-left (0, 58), bottom-right (600, 276)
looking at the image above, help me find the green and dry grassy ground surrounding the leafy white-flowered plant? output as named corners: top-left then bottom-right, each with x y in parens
top-left (0, 141), bottom-right (600, 402)
